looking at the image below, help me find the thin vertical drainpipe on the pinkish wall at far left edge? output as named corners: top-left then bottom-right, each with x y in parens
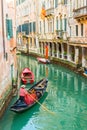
top-left (1, 0), bottom-right (5, 58)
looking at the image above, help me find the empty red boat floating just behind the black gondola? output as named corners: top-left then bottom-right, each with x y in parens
top-left (21, 68), bottom-right (34, 84)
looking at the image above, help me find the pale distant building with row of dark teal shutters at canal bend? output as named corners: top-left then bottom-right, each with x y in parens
top-left (16, 0), bottom-right (38, 52)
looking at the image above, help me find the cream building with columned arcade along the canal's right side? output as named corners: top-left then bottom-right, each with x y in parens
top-left (39, 0), bottom-right (87, 66)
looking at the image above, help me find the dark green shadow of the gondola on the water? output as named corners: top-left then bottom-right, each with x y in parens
top-left (11, 92), bottom-right (48, 130)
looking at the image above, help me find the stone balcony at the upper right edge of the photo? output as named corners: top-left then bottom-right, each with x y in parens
top-left (73, 6), bottom-right (87, 20)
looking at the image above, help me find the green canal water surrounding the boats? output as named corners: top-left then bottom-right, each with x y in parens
top-left (0, 56), bottom-right (87, 130)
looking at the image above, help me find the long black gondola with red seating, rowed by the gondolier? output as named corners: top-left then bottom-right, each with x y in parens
top-left (10, 78), bottom-right (48, 113)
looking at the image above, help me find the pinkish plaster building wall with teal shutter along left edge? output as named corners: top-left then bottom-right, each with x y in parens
top-left (0, 0), bottom-right (15, 116)
